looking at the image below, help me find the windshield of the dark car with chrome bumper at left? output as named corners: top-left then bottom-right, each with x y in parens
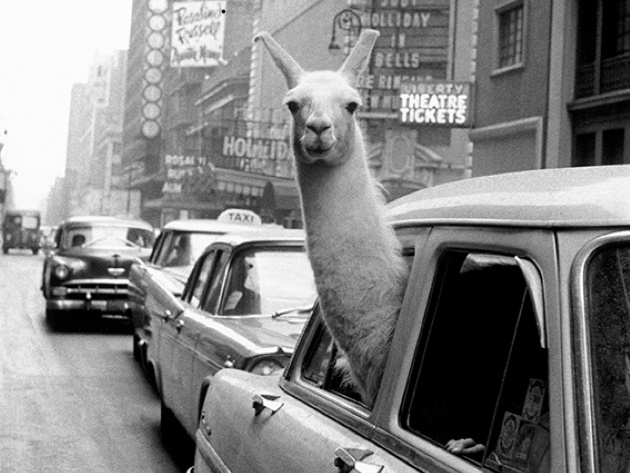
top-left (61, 225), bottom-right (153, 248)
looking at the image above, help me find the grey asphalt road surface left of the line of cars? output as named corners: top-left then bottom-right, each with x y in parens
top-left (0, 251), bottom-right (192, 473)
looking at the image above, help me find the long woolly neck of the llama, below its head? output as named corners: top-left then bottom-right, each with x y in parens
top-left (296, 132), bottom-right (406, 401)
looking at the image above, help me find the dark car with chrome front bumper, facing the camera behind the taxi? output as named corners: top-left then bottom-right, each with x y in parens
top-left (41, 216), bottom-right (154, 325)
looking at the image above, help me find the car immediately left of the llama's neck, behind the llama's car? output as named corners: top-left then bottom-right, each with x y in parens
top-left (146, 229), bottom-right (316, 439)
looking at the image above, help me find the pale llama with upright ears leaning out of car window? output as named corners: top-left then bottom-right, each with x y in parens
top-left (255, 30), bottom-right (407, 404)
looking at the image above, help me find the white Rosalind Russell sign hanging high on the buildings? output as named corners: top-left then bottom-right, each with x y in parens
top-left (171, 0), bottom-right (226, 67)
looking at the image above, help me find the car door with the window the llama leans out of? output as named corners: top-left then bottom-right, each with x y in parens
top-left (198, 315), bottom-right (415, 473)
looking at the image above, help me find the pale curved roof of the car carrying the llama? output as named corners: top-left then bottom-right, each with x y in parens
top-left (387, 165), bottom-right (630, 227)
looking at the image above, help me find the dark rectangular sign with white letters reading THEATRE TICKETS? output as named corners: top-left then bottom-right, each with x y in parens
top-left (400, 81), bottom-right (472, 128)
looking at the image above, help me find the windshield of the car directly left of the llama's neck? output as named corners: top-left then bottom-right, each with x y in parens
top-left (222, 248), bottom-right (316, 315)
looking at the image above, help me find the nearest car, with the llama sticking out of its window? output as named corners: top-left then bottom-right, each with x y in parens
top-left (194, 166), bottom-right (630, 473)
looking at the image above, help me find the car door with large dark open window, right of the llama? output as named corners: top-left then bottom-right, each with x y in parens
top-left (372, 226), bottom-right (566, 473)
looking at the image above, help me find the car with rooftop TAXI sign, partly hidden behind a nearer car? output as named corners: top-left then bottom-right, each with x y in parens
top-left (129, 216), bottom-right (262, 366)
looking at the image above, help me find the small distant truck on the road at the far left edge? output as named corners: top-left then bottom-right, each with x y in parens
top-left (2, 210), bottom-right (41, 255)
